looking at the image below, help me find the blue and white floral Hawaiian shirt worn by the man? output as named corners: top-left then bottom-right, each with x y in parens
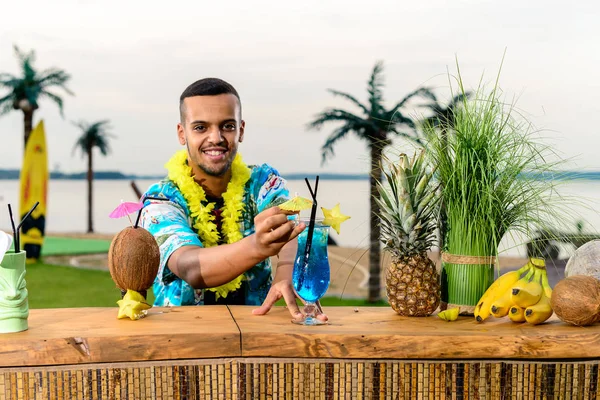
top-left (141, 164), bottom-right (289, 306)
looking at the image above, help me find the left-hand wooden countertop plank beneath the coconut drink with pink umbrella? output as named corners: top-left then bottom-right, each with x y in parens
top-left (0, 306), bottom-right (240, 366)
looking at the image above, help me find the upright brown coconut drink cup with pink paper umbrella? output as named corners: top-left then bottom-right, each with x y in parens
top-left (108, 227), bottom-right (160, 292)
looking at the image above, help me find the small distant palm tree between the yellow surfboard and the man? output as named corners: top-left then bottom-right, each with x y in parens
top-left (73, 120), bottom-right (114, 233)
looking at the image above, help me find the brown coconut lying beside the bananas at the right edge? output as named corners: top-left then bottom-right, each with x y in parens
top-left (550, 275), bottom-right (600, 326)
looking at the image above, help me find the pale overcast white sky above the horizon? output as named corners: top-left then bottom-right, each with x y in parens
top-left (0, 0), bottom-right (600, 175)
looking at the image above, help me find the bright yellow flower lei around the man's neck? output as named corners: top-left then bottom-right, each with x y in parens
top-left (165, 150), bottom-right (250, 299)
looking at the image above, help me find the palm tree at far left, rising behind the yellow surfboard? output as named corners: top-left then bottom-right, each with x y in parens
top-left (0, 46), bottom-right (73, 145)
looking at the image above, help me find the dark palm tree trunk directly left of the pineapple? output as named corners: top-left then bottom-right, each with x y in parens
top-left (368, 143), bottom-right (383, 303)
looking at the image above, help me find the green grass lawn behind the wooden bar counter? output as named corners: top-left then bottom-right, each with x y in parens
top-left (26, 263), bottom-right (387, 308)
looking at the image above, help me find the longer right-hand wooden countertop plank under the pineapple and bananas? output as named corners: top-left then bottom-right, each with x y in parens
top-left (229, 306), bottom-right (600, 360)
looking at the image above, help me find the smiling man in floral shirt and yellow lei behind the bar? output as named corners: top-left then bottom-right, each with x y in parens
top-left (142, 78), bottom-right (326, 319)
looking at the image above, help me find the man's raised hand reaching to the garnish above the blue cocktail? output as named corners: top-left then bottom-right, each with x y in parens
top-left (253, 207), bottom-right (305, 258)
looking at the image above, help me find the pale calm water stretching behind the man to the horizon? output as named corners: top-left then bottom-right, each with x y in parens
top-left (0, 180), bottom-right (600, 255)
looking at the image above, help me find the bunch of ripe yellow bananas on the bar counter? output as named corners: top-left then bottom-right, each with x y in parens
top-left (475, 258), bottom-right (553, 325)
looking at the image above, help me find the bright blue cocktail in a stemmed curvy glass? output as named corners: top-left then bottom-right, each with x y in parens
top-left (292, 220), bottom-right (330, 325)
